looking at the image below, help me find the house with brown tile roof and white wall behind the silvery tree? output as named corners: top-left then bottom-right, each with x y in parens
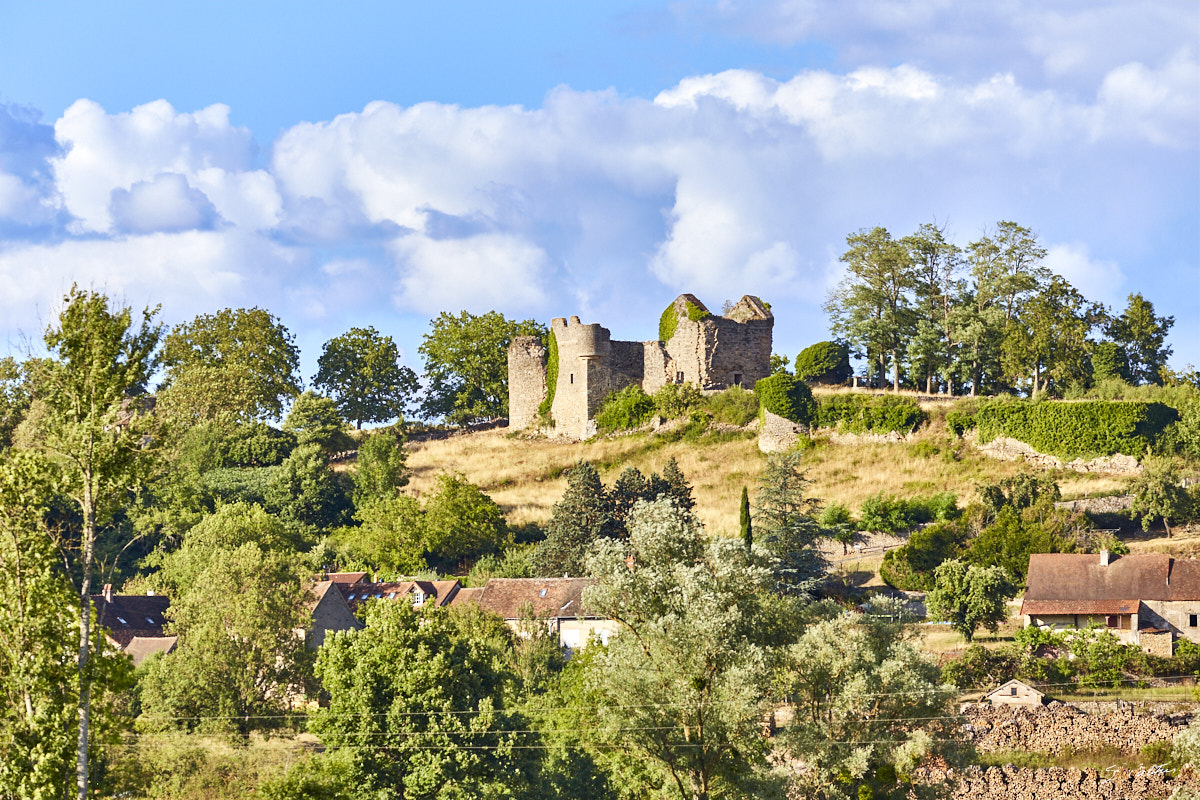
top-left (452, 578), bottom-right (617, 650)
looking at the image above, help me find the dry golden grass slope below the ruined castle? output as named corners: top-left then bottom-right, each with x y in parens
top-left (408, 404), bottom-right (1127, 533)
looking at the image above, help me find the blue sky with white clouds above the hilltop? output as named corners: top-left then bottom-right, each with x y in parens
top-left (0, 0), bottom-right (1200, 379)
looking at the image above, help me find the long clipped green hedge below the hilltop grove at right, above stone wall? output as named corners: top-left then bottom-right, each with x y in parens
top-left (974, 401), bottom-right (1178, 458)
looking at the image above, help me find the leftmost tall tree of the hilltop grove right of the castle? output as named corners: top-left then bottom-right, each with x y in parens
top-left (826, 228), bottom-right (916, 391)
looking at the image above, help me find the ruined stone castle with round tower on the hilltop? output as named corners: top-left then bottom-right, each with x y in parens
top-left (509, 294), bottom-right (775, 439)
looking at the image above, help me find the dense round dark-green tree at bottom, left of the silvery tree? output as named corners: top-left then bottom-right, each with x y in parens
top-left (312, 602), bottom-right (538, 800)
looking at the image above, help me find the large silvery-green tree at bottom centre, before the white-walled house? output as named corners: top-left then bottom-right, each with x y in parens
top-left (583, 499), bottom-right (779, 800)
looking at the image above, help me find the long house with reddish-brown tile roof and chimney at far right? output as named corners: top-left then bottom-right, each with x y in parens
top-left (1021, 551), bottom-right (1200, 656)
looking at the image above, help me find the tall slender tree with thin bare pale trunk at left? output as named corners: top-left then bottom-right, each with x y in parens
top-left (38, 287), bottom-right (162, 800)
